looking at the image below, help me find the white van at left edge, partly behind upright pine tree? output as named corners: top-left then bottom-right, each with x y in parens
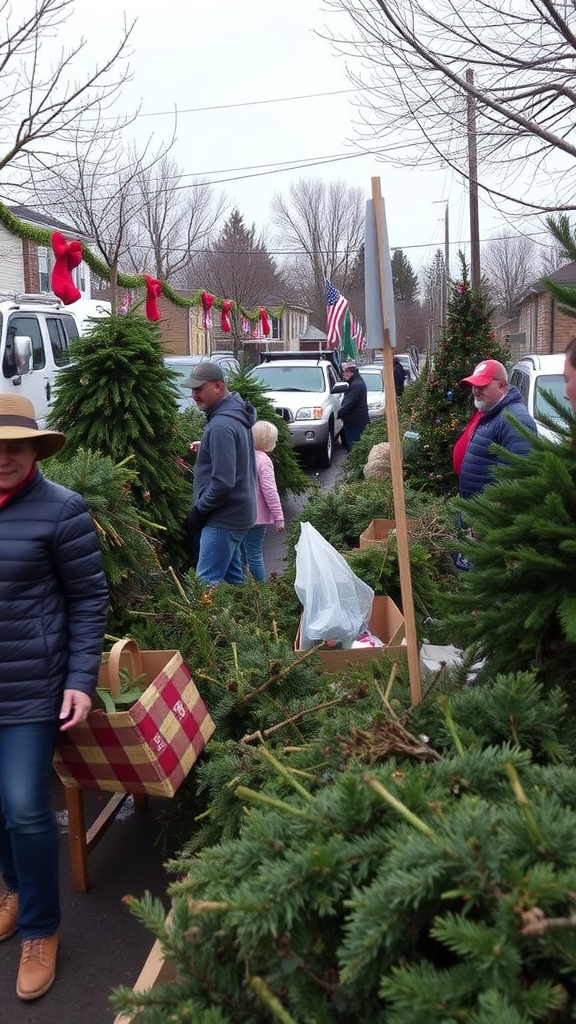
top-left (0, 293), bottom-right (111, 428)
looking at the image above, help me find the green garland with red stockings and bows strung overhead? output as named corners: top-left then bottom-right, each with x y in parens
top-left (0, 203), bottom-right (285, 325)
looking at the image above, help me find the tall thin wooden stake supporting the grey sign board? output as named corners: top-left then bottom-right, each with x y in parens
top-left (372, 178), bottom-right (422, 703)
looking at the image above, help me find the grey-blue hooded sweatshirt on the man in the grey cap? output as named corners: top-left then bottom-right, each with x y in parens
top-left (193, 391), bottom-right (256, 530)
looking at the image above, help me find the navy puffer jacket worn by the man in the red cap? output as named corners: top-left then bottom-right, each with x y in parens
top-left (459, 384), bottom-right (536, 498)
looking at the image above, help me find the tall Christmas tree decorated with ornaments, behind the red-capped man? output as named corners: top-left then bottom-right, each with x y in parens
top-left (407, 253), bottom-right (509, 490)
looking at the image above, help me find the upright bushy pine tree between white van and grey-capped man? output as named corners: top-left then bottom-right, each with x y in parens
top-left (49, 311), bottom-right (191, 562)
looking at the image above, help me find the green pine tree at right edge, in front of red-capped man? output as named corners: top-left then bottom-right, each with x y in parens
top-left (436, 396), bottom-right (576, 693)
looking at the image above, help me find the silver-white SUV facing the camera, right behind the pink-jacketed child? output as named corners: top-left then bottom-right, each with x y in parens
top-left (252, 351), bottom-right (347, 468)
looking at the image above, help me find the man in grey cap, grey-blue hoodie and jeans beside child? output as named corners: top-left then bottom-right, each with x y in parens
top-left (184, 359), bottom-right (256, 585)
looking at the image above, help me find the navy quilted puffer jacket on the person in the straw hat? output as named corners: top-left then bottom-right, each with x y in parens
top-left (0, 469), bottom-right (108, 725)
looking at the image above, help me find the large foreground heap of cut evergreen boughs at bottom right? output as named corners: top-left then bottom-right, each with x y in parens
top-left (108, 675), bottom-right (576, 1024)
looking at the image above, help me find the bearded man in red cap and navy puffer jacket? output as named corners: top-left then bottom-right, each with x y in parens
top-left (457, 359), bottom-right (536, 498)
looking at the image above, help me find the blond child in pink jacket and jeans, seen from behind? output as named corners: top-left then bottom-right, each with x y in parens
top-left (244, 420), bottom-right (284, 580)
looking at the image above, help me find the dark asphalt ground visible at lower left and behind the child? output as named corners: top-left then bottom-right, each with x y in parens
top-left (0, 445), bottom-right (346, 1024)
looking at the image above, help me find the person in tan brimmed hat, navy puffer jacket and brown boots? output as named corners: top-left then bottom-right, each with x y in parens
top-left (0, 395), bottom-right (108, 1000)
